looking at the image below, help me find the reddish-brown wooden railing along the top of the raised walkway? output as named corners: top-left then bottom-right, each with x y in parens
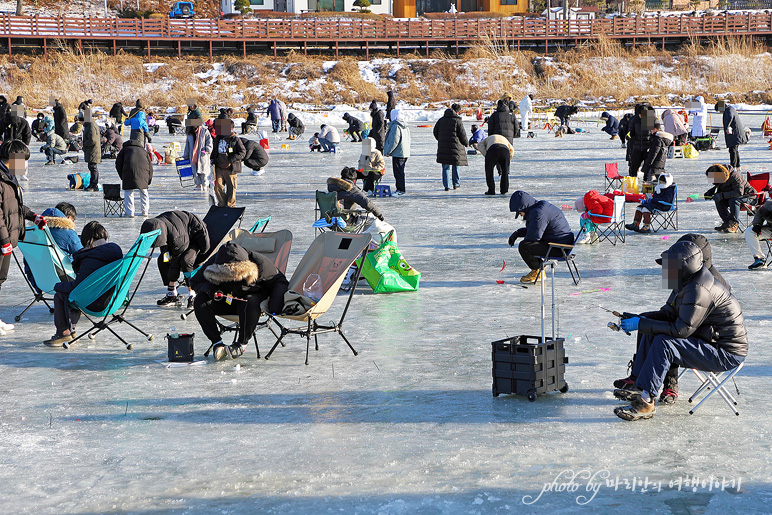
top-left (0, 13), bottom-right (772, 41)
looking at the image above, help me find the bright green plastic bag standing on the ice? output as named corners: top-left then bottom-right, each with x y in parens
top-left (362, 234), bottom-right (421, 293)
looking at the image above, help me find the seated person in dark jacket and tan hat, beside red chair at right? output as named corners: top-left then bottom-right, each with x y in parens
top-left (704, 164), bottom-right (756, 232)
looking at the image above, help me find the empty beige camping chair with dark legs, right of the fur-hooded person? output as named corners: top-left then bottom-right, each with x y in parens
top-left (261, 231), bottom-right (372, 365)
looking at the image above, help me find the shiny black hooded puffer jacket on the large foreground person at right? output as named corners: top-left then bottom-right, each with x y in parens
top-left (638, 241), bottom-right (748, 357)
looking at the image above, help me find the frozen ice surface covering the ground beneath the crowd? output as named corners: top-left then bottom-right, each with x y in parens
top-left (0, 114), bottom-right (772, 514)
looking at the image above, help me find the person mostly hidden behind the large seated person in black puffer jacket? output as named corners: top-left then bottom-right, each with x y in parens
top-left (614, 234), bottom-right (732, 404)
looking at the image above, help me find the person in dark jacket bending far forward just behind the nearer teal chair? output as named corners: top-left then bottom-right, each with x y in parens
top-left (140, 211), bottom-right (210, 307)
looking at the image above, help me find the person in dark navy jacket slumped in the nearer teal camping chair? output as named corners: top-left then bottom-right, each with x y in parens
top-left (43, 221), bottom-right (123, 347)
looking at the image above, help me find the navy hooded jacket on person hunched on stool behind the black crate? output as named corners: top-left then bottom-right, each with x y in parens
top-left (509, 191), bottom-right (574, 245)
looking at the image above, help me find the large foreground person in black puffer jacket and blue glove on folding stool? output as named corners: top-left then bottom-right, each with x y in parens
top-left (614, 241), bottom-right (748, 420)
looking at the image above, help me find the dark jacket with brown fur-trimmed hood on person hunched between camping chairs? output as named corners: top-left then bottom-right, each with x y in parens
top-left (190, 241), bottom-right (289, 313)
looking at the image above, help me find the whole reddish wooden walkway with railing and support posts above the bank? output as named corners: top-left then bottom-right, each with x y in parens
top-left (0, 12), bottom-right (772, 57)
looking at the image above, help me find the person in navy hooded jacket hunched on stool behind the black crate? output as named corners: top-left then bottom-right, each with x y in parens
top-left (509, 190), bottom-right (574, 283)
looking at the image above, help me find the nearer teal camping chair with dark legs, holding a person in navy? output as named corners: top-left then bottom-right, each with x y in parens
top-left (63, 229), bottom-right (161, 350)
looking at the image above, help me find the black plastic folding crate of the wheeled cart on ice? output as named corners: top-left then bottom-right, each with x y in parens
top-left (491, 335), bottom-right (568, 402)
